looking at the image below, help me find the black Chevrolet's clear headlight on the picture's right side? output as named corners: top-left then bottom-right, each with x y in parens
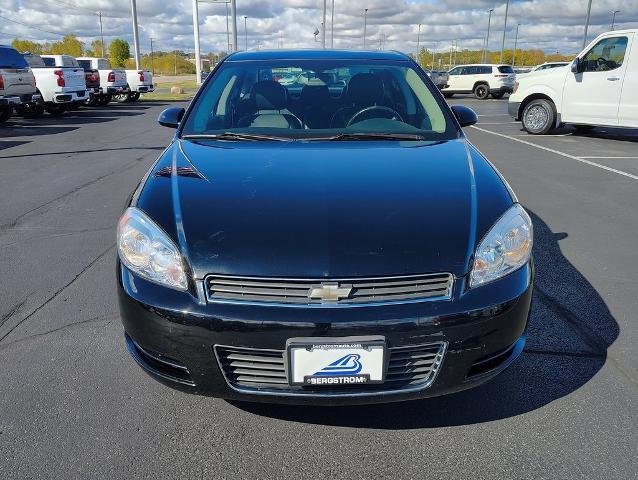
top-left (470, 203), bottom-right (533, 287)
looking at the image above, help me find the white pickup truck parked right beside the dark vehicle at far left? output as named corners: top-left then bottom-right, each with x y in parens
top-left (16, 53), bottom-right (89, 118)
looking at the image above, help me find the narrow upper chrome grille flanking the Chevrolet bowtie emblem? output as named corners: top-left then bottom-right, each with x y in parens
top-left (204, 273), bottom-right (453, 305)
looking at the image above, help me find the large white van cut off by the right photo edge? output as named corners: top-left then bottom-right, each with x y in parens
top-left (508, 29), bottom-right (638, 135)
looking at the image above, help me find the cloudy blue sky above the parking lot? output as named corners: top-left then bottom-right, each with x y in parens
top-left (0, 0), bottom-right (638, 53)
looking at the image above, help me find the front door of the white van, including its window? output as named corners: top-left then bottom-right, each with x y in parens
top-left (561, 34), bottom-right (629, 125)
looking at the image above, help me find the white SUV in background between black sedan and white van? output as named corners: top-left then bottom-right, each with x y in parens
top-left (443, 64), bottom-right (516, 100)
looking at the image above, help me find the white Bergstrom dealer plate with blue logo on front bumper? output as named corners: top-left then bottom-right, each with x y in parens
top-left (287, 337), bottom-right (385, 387)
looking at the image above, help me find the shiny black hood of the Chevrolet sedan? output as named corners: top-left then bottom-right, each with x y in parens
top-left (138, 138), bottom-right (512, 278)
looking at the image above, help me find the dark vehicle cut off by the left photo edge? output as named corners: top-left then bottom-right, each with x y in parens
top-left (0, 45), bottom-right (40, 123)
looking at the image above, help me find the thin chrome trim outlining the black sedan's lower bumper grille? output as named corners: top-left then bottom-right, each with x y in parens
top-left (213, 342), bottom-right (448, 398)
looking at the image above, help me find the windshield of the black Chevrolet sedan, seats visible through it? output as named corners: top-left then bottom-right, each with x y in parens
top-left (182, 59), bottom-right (458, 141)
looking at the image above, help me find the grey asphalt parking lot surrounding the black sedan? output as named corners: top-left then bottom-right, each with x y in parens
top-left (0, 97), bottom-right (638, 480)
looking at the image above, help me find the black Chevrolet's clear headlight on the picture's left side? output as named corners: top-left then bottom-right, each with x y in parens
top-left (117, 208), bottom-right (188, 290)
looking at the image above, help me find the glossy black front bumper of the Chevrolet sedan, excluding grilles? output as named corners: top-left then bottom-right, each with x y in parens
top-left (117, 264), bottom-right (533, 405)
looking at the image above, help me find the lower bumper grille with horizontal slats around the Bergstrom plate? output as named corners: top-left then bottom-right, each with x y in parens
top-left (215, 342), bottom-right (446, 394)
